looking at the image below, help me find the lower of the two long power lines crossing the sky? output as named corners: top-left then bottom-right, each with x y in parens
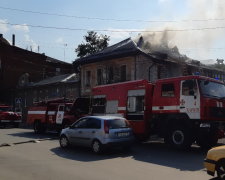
top-left (0, 22), bottom-right (225, 33)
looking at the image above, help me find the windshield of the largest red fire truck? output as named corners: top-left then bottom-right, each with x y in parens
top-left (199, 80), bottom-right (225, 98)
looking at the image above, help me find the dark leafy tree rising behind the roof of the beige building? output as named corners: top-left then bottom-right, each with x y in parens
top-left (75, 31), bottom-right (110, 57)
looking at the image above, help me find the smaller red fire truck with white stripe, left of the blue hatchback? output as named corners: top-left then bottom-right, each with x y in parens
top-left (27, 98), bottom-right (90, 133)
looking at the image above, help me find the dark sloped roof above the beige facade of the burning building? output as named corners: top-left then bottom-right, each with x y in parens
top-left (73, 38), bottom-right (156, 66)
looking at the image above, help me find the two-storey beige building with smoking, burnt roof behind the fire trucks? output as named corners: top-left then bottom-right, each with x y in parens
top-left (73, 38), bottom-right (225, 96)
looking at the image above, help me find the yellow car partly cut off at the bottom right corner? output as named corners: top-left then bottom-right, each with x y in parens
top-left (204, 146), bottom-right (225, 180)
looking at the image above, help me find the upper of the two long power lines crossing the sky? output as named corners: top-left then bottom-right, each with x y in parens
top-left (0, 6), bottom-right (225, 23)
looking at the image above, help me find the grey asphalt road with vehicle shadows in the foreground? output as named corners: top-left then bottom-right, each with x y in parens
top-left (0, 129), bottom-right (222, 180)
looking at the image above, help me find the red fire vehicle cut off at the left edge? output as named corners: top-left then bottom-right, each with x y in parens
top-left (0, 104), bottom-right (22, 127)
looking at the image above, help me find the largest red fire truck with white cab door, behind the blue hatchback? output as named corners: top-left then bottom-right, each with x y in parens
top-left (92, 76), bottom-right (225, 149)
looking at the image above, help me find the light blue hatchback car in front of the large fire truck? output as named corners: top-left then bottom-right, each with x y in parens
top-left (59, 116), bottom-right (134, 153)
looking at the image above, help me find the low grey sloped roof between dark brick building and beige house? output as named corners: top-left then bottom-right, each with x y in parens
top-left (30, 73), bottom-right (79, 86)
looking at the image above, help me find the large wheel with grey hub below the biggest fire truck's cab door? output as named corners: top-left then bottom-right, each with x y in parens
top-left (169, 126), bottom-right (192, 149)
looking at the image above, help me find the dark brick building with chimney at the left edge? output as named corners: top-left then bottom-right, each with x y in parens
top-left (0, 34), bottom-right (73, 104)
